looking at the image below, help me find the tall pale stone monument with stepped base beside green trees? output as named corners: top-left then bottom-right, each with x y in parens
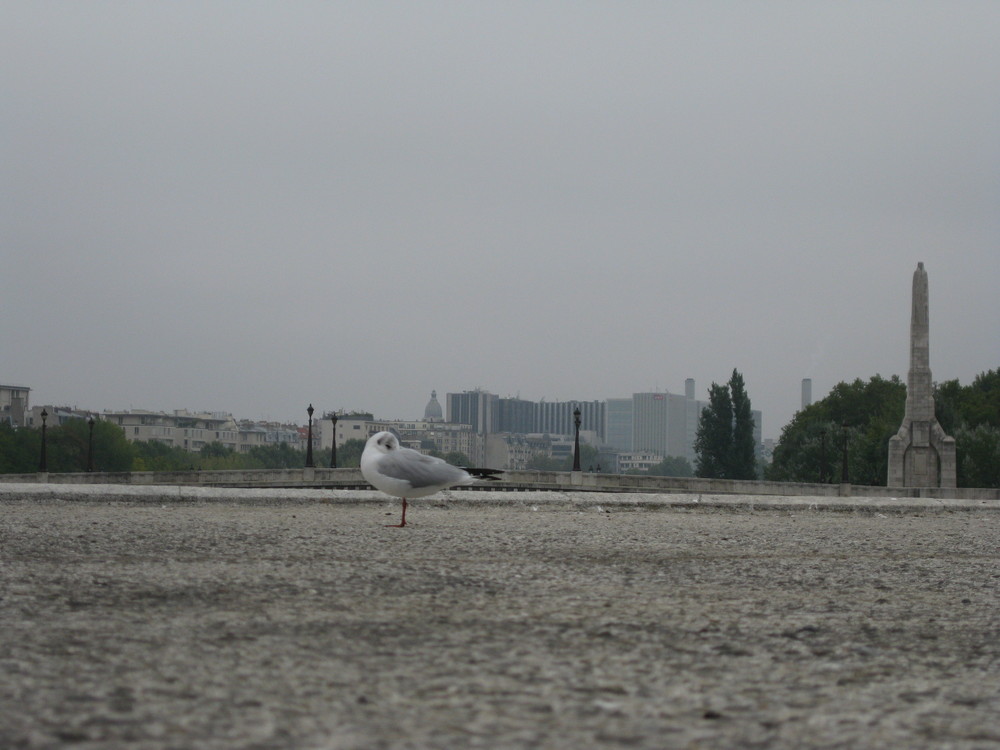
top-left (888, 263), bottom-right (956, 488)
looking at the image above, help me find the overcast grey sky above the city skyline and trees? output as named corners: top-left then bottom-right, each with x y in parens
top-left (0, 0), bottom-right (1000, 437)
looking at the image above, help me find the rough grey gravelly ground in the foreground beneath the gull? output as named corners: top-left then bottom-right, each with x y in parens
top-left (0, 497), bottom-right (1000, 750)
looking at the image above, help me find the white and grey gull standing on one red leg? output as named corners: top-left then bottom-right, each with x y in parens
top-left (361, 432), bottom-right (500, 528)
